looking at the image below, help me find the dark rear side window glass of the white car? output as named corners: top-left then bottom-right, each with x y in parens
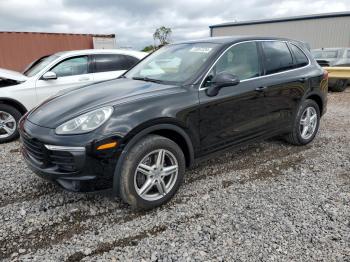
top-left (95, 54), bottom-right (137, 73)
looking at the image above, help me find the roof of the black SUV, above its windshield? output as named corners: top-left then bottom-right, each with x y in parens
top-left (174, 35), bottom-right (292, 44)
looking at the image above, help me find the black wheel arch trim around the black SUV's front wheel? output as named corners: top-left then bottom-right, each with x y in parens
top-left (113, 123), bottom-right (194, 195)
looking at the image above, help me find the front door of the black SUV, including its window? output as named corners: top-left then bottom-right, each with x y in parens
top-left (199, 41), bottom-right (268, 154)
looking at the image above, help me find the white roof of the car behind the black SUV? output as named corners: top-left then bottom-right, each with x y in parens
top-left (55, 49), bottom-right (148, 59)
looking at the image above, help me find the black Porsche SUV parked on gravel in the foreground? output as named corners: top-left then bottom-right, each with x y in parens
top-left (20, 37), bottom-right (328, 209)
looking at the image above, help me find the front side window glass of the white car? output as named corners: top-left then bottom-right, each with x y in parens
top-left (50, 56), bottom-right (88, 77)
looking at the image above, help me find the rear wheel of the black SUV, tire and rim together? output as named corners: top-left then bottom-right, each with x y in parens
top-left (286, 99), bottom-right (320, 145)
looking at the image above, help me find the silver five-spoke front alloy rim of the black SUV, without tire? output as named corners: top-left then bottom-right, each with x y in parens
top-left (134, 149), bottom-right (179, 201)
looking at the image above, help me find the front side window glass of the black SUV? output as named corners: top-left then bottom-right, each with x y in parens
top-left (204, 42), bottom-right (260, 87)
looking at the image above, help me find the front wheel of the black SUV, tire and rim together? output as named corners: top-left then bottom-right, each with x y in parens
top-left (119, 135), bottom-right (185, 210)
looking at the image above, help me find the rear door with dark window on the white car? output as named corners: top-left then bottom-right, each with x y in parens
top-left (93, 54), bottom-right (139, 81)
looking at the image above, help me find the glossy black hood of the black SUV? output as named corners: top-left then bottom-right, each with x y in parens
top-left (27, 79), bottom-right (175, 128)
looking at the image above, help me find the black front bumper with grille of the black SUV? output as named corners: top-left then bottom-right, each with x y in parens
top-left (19, 116), bottom-right (120, 192)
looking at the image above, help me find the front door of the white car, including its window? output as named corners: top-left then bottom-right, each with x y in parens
top-left (36, 55), bottom-right (94, 103)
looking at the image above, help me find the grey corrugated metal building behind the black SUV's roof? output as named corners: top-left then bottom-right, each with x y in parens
top-left (209, 12), bottom-right (350, 48)
